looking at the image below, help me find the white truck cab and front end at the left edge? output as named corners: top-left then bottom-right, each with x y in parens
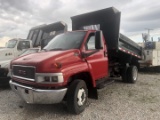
top-left (0, 38), bottom-right (32, 86)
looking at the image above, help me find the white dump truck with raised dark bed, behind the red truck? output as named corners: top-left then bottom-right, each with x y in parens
top-left (0, 21), bottom-right (67, 86)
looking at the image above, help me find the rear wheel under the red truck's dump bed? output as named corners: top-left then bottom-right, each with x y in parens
top-left (127, 66), bottom-right (138, 83)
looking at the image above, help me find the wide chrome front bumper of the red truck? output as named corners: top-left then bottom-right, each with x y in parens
top-left (9, 80), bottom-right (67, 104)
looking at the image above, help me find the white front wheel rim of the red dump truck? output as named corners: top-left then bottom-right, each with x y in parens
top-left (77, 88), bottom-right (86, 106)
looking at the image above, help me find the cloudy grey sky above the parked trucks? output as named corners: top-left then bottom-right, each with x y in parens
top-left (0, 0), bottom-right (160, 47)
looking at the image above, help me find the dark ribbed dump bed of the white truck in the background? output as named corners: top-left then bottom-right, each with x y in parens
top-left (27, 21), bottom-right (67, 47)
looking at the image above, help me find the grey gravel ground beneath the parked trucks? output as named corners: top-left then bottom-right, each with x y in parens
top-left (0, 73), bottom-right (160, 120)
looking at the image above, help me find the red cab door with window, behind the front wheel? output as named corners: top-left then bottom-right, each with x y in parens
top-left (85, 32), bottom-right (108, 80)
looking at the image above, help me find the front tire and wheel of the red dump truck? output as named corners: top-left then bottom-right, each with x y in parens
top-left (67, 80), bottom-right (88, 114)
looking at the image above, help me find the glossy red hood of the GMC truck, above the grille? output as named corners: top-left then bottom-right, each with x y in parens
top-left (12, 49), bottom-right (81, 72)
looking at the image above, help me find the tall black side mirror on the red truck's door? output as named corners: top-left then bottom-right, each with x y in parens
top-left (95, 31), bottom-right (103, 49)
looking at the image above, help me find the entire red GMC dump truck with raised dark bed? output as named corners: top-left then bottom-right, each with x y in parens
top-left (10, 7), bottom-right (141, 114)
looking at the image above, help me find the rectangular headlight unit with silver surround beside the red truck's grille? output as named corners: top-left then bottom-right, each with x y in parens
top-left (36, 73), bottom-right (64, 83)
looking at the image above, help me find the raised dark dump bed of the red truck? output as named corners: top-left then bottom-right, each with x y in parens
top-left (71, 7), bottom-right (141, 58)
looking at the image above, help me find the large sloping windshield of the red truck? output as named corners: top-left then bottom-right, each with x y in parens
top-left (44, 32), bottom-right (86, 50)
